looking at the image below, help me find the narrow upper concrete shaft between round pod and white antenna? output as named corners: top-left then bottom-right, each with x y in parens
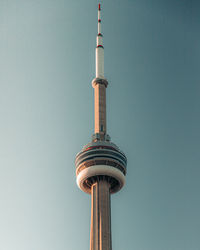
top-left (94, 84), bottom-right (106, 134)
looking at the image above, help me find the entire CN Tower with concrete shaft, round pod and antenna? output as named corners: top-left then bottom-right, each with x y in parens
top-left (75, 4), bottom-right (127, 250)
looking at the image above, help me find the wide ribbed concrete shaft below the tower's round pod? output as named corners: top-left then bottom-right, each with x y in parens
top-left (90, 180), bottom-right (112, 250)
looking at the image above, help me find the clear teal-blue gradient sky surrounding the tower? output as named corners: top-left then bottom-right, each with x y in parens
top-left (0, 0), bottom-right (200, 250)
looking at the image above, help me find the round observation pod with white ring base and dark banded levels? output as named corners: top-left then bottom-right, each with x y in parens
top-left (75, 141), bottom-right (127, 194)
